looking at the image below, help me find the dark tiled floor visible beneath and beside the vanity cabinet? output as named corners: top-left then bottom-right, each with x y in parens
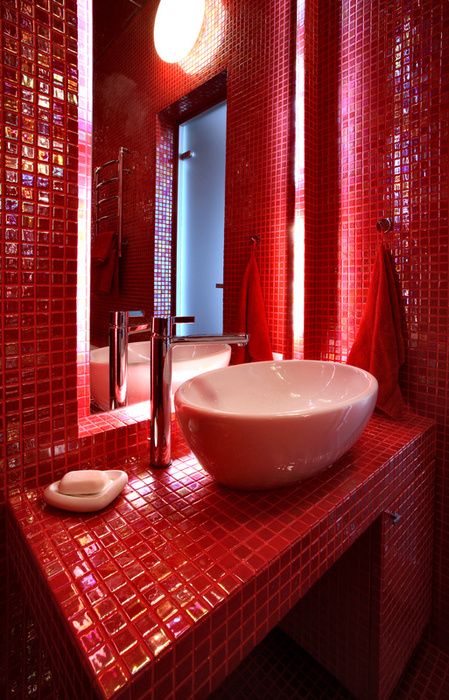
top-left (211, 629), bottom-right (449, 700)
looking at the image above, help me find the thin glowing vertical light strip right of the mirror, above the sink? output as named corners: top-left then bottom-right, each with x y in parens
top-left (293, 0), bottom-right (305, 358)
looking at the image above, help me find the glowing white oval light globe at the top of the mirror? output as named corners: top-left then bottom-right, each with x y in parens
top-left (154, 0), bottom-right (206, 63)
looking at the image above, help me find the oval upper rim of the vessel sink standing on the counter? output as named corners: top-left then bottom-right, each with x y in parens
top-left (174, 359), bottom-right (378, 421)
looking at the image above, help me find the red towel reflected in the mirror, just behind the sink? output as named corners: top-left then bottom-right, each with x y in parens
top-left (233, 250), bottom-right (273, 364)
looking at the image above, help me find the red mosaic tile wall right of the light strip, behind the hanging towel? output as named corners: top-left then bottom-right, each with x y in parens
top-left (305, 0), bottom-right (449, 648)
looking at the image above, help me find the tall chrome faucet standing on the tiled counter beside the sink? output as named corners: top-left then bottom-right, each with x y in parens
top-left (150, 316), bottom-right (248, 467)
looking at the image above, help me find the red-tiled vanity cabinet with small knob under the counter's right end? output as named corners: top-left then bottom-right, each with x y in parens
top-left (281, 463), bottom-right (434, 700)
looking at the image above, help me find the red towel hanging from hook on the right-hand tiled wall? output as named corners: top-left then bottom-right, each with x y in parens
top-left (348, 243), bottom-right (406, 419)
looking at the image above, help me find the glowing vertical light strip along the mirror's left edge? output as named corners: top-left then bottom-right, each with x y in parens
top-left (76, 0), bottom-right (93, 416)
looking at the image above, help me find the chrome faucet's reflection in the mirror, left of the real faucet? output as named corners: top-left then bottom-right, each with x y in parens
top-left (109, 311), bottom-right (151, 409)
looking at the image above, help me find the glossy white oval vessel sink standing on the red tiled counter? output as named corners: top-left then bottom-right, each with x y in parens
top-left (175, 360), bottom-right (377, 489)
